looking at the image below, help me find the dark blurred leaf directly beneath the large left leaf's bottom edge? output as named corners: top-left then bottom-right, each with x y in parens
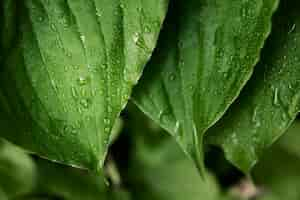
top-left (32, 159), bottom-right (106, 200)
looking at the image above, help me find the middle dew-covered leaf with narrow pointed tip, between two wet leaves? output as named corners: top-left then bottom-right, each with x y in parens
top-left (133, 0), bottom-right (277, 173)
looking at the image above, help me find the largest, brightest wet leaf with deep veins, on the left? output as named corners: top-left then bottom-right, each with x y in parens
top-left (0, 0), bottom-right (168, 170)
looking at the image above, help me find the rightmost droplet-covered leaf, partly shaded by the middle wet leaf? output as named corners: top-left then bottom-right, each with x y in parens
top-left (208, 0), bottom-right (300, 172)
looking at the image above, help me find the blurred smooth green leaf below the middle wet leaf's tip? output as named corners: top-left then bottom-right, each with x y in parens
top-left (126, 107), bottom-right (225, 200)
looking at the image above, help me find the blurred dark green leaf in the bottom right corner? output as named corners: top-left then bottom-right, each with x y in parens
top-left (253, 120), bottom-right (300, 200)
